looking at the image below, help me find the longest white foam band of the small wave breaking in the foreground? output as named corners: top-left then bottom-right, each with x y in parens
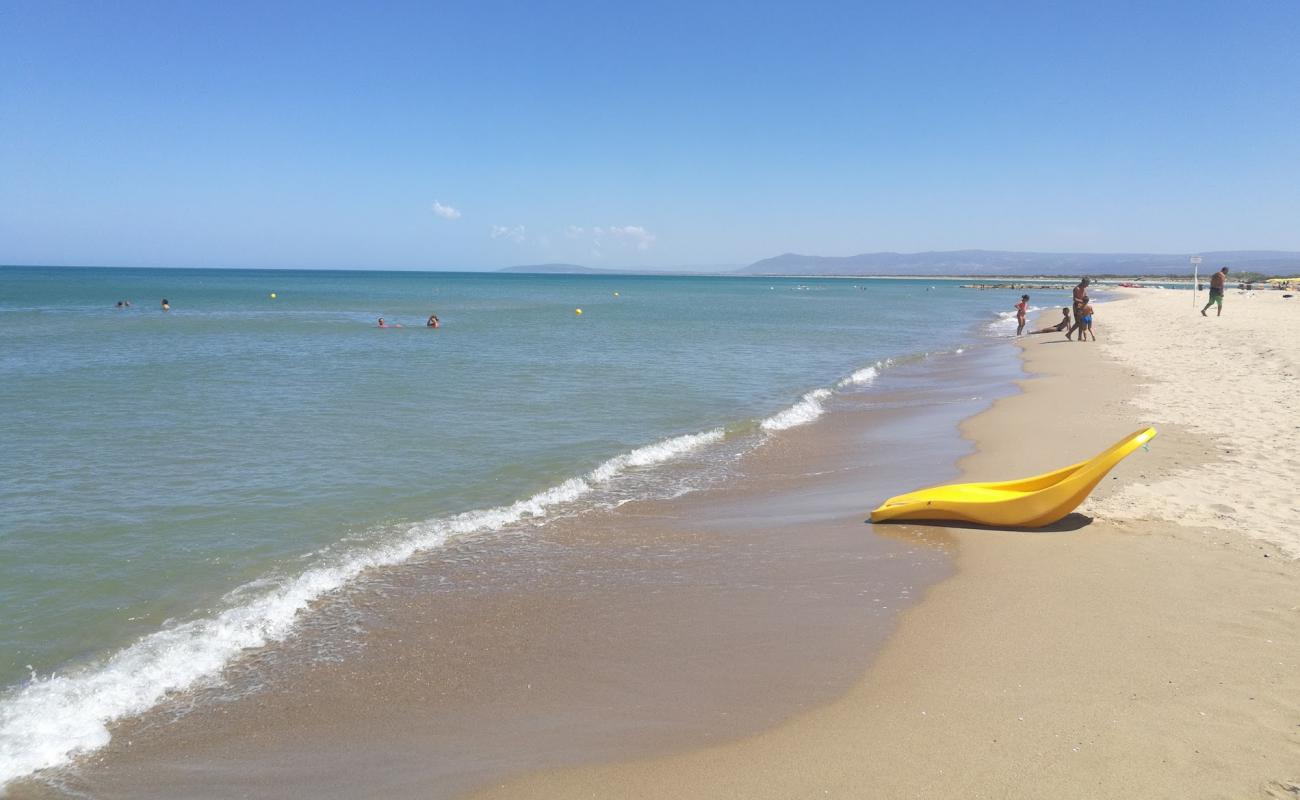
top-left (0, 429), bottom-right (724, 792)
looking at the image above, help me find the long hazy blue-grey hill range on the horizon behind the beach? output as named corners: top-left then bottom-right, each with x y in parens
top-left (740, 250), bottom-right (1300, 276)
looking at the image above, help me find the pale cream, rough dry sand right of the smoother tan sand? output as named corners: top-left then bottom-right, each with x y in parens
top-left (1087, 290), bottom-right (1300, 558)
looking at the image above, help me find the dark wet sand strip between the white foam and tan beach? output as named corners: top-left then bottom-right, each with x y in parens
top-left (12, 345), bottom-right (1019, 797)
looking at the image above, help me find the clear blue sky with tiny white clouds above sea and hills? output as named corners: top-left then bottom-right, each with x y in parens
top-left (0, 0), bottom-right (1300, 269)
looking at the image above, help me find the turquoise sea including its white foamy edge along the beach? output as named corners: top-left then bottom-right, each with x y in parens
top-left (0, 268), bottom-right (1062, 786)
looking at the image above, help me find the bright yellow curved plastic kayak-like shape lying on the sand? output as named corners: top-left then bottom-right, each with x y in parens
top-left (871, 428), bottom-right (1156, 528)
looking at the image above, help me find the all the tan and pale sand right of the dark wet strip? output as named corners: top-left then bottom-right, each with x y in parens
top-left (476, 290), bottom-right (1300, 797)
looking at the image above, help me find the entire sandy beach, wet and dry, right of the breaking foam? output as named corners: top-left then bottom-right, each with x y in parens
top-left (9, 290), bottom-right (1300, 799)
